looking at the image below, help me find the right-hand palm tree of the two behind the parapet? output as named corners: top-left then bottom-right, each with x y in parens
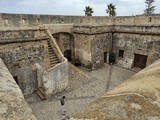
top-left (106, 3), bottom-right (116, 16)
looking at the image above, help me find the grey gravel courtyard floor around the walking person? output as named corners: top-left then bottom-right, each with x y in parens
top-left (26, 64), bottom-right (136, 120)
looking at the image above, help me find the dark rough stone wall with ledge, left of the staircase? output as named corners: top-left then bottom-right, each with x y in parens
top-left (0, 29), bottom-right (50, 94)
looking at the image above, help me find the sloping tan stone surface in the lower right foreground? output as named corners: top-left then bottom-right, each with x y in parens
top-left (75, 60), bottom-right (160, 120)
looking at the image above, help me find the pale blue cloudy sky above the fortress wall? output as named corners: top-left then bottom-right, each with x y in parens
top-left (0, 0), bottom-right (160, 16)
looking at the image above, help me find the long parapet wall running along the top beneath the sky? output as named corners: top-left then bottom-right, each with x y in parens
top-left (0, 13), bottom-right (160, 27)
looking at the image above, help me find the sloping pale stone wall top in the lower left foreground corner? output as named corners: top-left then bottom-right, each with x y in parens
top-left (0, 59), bottom-right (36, 120)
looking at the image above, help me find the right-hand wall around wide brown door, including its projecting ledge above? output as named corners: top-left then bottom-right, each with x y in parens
top-left (113, 26), bottom-right (160, 68)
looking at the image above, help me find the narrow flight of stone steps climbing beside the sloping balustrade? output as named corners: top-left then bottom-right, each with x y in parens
top-left (48, 41), bottom-right (59, 68)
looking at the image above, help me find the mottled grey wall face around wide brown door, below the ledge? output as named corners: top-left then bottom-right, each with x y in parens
top-left (113, 33), bottom-right (160, 68)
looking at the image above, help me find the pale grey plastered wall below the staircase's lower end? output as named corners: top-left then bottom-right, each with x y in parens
top-left (43, 60), bottom-right (68, 95)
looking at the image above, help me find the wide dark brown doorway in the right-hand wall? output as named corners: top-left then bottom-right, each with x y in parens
top-left (134, 54), bottom-right (147, 69)
